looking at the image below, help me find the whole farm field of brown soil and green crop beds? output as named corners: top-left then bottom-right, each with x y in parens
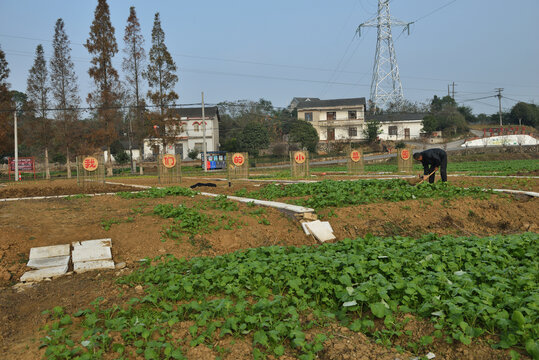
top-left (0, 169), bottom-right (539, 360)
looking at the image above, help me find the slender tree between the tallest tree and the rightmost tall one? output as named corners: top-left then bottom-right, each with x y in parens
top-left (122, 6), bottom-right (147, 165)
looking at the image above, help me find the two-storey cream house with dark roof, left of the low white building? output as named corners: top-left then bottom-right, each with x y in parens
top-left (289, 98), bottom-right (365, 142)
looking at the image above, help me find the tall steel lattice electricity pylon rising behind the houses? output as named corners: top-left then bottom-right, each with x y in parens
top-left (357, 0), bottom-right (412, 112)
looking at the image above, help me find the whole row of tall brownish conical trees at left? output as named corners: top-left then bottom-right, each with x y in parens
top-left (0, 0), bottom-right (178, 178)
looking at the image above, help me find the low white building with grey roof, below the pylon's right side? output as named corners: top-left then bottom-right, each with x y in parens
top-left (366, 113), bottom-right (427, 141)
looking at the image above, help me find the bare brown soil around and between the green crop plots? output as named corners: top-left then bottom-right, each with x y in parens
top-left (0, 178), bottom-right (539, 360)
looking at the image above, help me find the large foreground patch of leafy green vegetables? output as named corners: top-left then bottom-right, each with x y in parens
top-left (43, 233), bottom-right (539, 359)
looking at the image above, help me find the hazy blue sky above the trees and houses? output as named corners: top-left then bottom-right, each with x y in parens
top-left (0, 0), bottom-right (539, 114)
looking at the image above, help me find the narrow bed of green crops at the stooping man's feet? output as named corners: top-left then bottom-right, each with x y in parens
top-left (236, 179), bottom-right (491, 209)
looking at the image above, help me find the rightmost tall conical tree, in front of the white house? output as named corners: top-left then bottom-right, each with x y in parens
top-left (144, 13), bottom-right (182, 149)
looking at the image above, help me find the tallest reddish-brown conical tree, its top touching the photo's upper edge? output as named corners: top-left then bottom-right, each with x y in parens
top-left (84, 0), bottom-right (121, 176)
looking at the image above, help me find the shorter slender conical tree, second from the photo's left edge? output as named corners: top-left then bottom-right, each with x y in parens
top-left (26, 44), bottom-right (52, 179)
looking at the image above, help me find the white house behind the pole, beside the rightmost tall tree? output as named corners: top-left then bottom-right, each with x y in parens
top-left (144, 106), bottom-right (220, 159)
